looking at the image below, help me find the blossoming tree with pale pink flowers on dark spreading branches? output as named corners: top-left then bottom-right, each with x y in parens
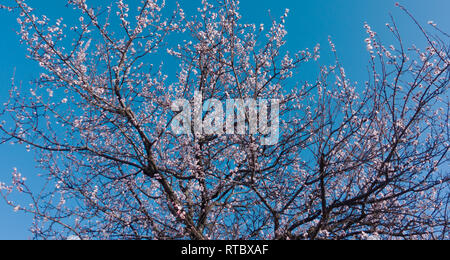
top-left (0, 0), bottom-right (450, 240)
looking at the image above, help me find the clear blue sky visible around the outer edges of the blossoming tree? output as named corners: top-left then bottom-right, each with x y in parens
top-left (0, 0), bottom-right (450, 239)
